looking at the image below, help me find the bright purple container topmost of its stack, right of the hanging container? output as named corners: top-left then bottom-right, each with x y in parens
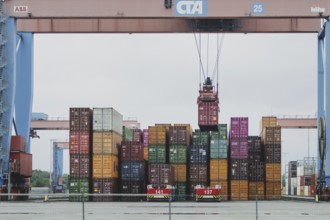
top-left (230, 117), bottom-right (249, 138)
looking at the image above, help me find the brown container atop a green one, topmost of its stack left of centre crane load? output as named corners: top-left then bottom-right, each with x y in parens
top-left (169, 126), bottom-right (191, 146)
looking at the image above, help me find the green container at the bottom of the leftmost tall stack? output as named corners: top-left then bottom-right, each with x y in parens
top-left (69, 178), bottom-right (89, 202)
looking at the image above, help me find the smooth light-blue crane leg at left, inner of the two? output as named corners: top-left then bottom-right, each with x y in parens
top-left (15, 33), bottom-right (33, 153)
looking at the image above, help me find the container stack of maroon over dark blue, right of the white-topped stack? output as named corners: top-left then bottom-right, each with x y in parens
top-left (120, 141), bottom-right (147, 201)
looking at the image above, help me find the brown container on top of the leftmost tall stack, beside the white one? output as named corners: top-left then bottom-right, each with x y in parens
top-left (70, 108), bottom-right (92, 131)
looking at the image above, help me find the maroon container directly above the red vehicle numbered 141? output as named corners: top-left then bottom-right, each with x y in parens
top-left (149, 164), bottom-right (174, 187)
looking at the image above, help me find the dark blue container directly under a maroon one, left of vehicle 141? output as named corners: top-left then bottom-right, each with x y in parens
top-left (121, 161), bottom-right (147, 181)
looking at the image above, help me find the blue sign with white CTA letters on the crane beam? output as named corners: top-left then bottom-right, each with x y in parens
top-left (174, 0), bottom-right (207, 16)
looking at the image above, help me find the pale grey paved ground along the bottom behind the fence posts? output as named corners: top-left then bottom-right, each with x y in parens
top-left (0, 200), bottom-right (330, 220)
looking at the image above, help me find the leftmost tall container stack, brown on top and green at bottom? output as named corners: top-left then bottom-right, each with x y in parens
top-left (69, 108), bottom-right (92, 201)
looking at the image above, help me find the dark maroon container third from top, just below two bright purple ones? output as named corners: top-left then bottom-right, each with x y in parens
top-left (229, 159), bottom-right (248, 180)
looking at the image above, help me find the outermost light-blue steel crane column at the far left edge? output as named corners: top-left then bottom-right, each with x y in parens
top-left (0, 18), bottom-right (16, 177)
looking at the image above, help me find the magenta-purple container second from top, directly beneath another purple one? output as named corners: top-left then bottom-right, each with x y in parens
top-left (229, 138), bottom-right (248, 159)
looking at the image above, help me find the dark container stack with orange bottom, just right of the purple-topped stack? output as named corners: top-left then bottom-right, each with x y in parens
top-left (248, 136), bottom-right (265, 200)
